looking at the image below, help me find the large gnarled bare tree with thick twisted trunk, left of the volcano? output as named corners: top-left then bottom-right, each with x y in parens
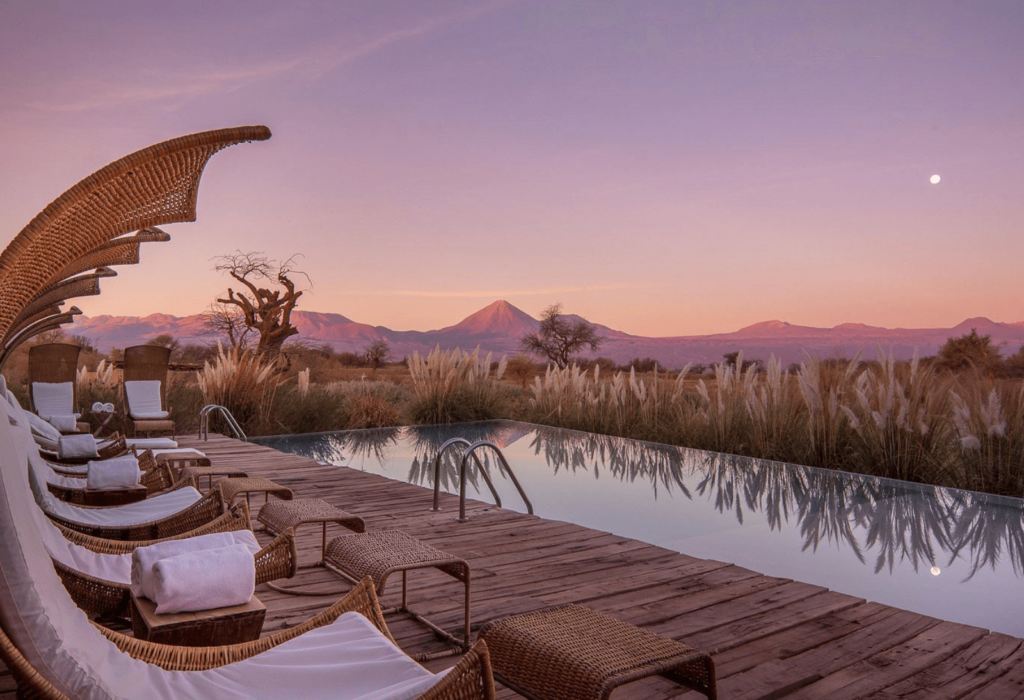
top-left (214, 251), bottom-right (309, 356)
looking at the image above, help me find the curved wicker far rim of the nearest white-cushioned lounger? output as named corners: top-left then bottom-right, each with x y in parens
top-left (96, 577), bottom-right (397, 670)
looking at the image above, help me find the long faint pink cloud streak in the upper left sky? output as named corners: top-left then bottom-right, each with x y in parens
top-left (25, 1), bottom-right (508, 113)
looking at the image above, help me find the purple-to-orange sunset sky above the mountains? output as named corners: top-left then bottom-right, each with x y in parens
top-left (0, 0), bottom-right (1024, 336)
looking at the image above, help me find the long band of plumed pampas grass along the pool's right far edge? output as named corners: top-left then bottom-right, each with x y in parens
top-left (527, 349), bottom-right (1024, 497)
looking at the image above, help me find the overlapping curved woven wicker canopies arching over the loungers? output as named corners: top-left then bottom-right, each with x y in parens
top-left (0, 126), bottom-right (270, 350)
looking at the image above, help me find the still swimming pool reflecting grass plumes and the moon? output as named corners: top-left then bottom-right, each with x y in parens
top-left (253, 421), bottom-right (1024, 637)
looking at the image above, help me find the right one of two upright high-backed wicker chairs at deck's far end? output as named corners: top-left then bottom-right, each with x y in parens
top-left (121, 345), bottom-right (174, 434)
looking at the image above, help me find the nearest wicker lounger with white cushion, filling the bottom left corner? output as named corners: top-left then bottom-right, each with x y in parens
top-left (0, 392), bottom-right (495, 699)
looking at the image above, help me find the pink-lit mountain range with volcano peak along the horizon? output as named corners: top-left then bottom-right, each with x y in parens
top-left (68, 301), bottom-right (1024, 367)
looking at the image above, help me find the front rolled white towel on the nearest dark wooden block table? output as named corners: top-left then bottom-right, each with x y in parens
top-left (153, 544), bottom-right (256, 615)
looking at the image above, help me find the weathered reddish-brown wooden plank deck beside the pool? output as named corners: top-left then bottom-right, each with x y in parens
top-left (8, 436), bottom-right (1024, 700)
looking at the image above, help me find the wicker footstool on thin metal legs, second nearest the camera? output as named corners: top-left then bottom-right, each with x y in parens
top-left (324, 530), bottom-right (471, 661)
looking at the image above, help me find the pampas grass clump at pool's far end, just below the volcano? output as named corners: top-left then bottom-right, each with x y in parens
top-left (409, 347), bottom-right (507, 424)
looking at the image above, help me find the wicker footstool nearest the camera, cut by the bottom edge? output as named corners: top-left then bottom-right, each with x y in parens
top-left (479, 605), bottom-right (718, 700)
